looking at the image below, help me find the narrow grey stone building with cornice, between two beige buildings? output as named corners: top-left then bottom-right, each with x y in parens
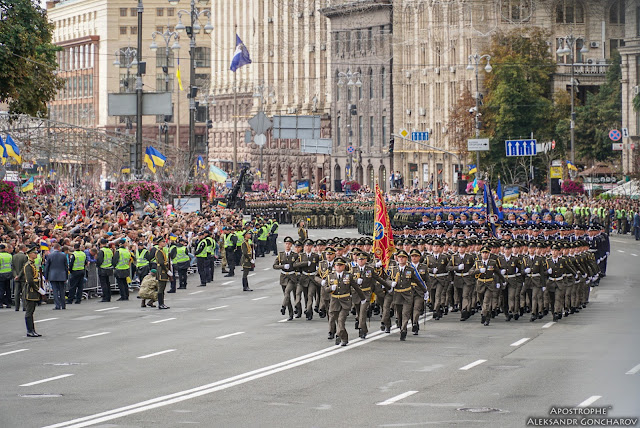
top-left (321, 0), bottom-right (393, 189)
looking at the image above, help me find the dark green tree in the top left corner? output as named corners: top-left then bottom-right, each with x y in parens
top-left (0, 0), bottom-right (62, 116)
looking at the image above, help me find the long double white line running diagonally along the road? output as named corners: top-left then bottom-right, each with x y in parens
top-left (45, 327), bottom-right (390, 428)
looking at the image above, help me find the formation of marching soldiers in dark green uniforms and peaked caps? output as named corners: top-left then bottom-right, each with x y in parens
top-left (273, 229), bottom-right (608, 346)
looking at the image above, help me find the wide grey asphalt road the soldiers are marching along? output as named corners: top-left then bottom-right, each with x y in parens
top-left (0, 226), bottom-right (640, 427)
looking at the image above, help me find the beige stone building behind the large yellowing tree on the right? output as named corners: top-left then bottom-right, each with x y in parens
top-left (393, 0), bottom-right (636, 187)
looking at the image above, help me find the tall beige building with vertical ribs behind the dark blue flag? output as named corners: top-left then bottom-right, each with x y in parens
top-left (209, 0), bottom-right (332, 188)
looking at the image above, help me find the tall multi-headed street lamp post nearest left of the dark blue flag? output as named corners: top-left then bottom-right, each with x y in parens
top-left (169, 0), bottom-right (213, 174)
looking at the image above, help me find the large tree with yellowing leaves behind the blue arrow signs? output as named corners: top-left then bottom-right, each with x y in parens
top-left (481, 28), bottom-right (557, 184)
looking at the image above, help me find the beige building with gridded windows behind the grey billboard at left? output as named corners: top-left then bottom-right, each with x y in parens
top-left (47, 0), bottom-right (211, 164)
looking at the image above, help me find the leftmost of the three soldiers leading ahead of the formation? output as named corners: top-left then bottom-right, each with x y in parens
top-left (322, 257), bottom-right (366, 346)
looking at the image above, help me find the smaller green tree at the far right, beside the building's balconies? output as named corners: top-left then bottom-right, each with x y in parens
top-left (575, 51), bottom-right (622, 161)
